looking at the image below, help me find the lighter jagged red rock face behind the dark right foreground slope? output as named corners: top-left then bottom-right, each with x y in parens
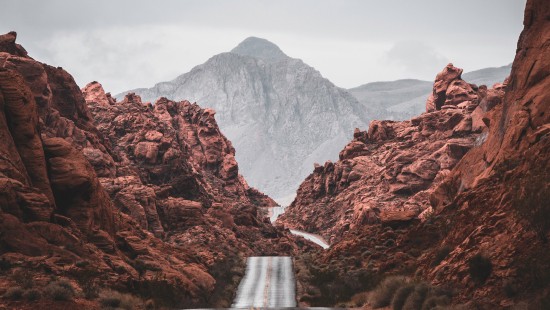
top-left (280, 65), bottom-right (504, 242)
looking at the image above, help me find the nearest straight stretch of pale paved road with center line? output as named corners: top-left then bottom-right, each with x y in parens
top-left (232, 256), bottom-right (296, 308)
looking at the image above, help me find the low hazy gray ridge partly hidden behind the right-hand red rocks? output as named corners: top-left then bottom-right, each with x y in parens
top-left (348, 64), bottom-right (512, 120)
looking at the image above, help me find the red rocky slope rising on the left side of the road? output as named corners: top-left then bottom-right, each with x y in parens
top-left (0, 32), bottom-right (294, 309)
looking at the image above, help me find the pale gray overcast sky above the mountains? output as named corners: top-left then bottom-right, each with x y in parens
top-left (0, 0), bottom-right (525, 93)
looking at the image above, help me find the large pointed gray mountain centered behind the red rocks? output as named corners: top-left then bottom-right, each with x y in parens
top-left (124, 37), bottom-right (368, 203)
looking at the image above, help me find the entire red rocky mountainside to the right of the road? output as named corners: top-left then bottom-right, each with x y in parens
top-left (282, 0), bottom-right (550, 309)
